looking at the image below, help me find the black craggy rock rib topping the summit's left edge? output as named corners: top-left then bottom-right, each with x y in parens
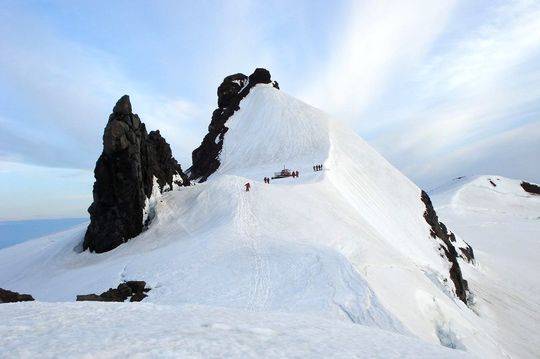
top-left (187, 68), bottom-right (279, 182)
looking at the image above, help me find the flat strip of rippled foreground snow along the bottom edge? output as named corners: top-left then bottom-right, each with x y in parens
top-left (0, 303), bottom-right (467, 358)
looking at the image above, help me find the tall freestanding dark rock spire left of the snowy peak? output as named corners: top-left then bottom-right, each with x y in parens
top-left (83, 95), bottom-right (189, 253)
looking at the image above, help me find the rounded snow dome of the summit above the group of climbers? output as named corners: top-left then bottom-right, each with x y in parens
top-left (214, 84), bottom-right (330, 175)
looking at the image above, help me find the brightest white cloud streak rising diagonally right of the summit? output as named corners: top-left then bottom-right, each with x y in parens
top-left (303, 1), bottom-right (454, 123)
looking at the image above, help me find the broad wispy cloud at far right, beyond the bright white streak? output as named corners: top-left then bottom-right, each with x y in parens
top-left (376, 3), bottom-right (540, 186)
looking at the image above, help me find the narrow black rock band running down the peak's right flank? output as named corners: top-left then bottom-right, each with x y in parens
top-left (420, 191), bottom-right (474, 304)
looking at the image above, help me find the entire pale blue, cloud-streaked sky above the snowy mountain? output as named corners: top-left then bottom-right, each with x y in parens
top-left (0, 0), bottom-right (540, 220)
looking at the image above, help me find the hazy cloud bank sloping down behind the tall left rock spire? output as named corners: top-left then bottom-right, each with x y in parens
top-left (0, 5), bottom-right (207, 169)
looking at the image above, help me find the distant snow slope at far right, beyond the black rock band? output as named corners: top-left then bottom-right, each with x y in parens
top-left (431, 175), bottom-right (540, 358)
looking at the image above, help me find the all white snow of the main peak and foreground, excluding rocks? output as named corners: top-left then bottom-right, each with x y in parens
top-left (0, 84), bottom-right (534, 358)
